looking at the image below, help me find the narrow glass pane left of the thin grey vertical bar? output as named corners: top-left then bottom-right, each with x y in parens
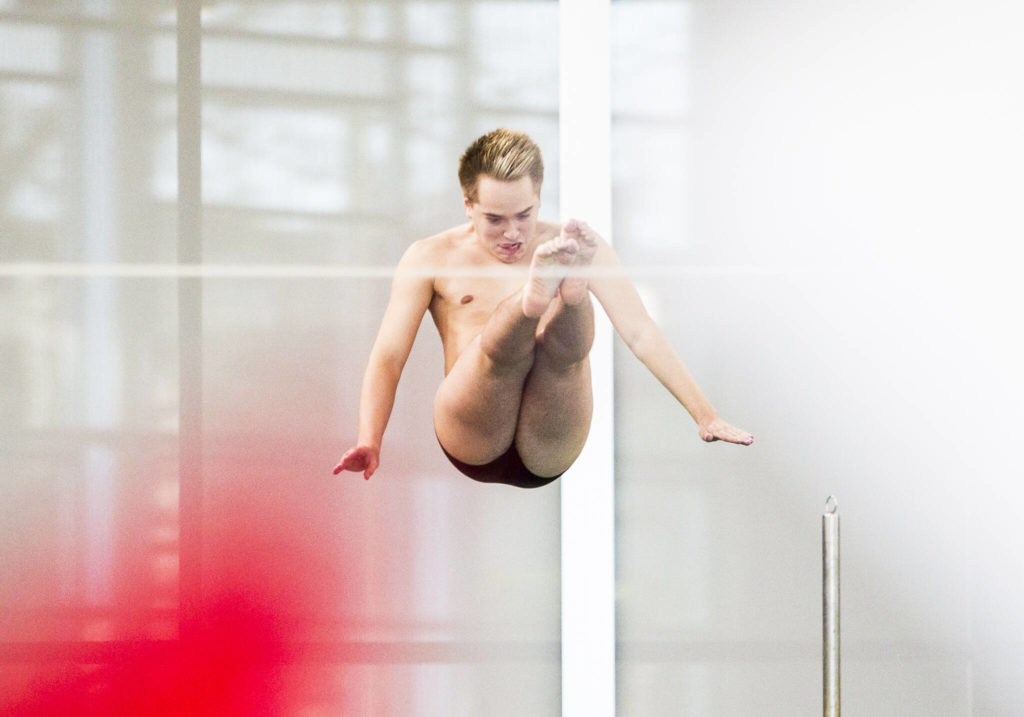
top-left (0, 2), bottom-right (178, 714)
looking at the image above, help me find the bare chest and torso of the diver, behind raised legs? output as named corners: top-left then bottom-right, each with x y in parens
top-left (422, 221), bottom-right (560, 375)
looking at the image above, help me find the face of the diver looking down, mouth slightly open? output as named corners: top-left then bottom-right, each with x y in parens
top-left (466, 175), bottom-right (541, 264)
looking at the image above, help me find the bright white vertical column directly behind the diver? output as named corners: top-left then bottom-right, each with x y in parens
top-left (559, 0), bottom-right (615, 717)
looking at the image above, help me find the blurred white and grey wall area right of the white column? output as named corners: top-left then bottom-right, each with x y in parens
top-left (613, 0), bottom-right (1024, 717)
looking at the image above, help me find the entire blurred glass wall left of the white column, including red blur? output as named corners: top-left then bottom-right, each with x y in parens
top-left (0, 0), bottom-right (560, 717)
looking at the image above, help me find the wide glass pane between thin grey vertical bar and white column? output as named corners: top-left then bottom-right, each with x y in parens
top-left (193, 2), bottom-right (559, 715)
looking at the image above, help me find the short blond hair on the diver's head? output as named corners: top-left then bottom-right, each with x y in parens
top-left (459, 129), bottom-right (544, 202)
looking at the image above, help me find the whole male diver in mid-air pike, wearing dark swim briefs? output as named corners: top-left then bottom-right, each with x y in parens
top-left (334, 129), bottom-right (754, 488)
